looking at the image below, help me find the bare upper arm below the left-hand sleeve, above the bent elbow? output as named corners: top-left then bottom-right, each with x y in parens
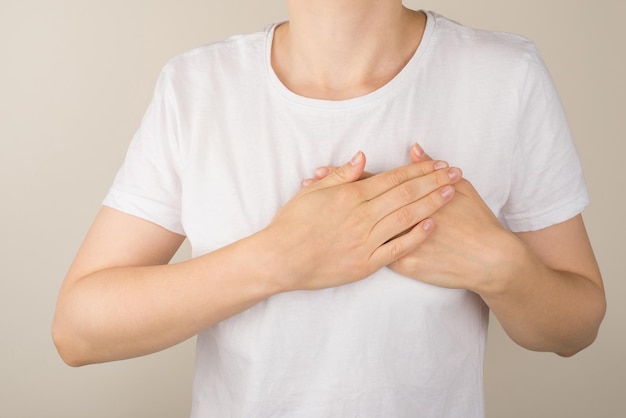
top-left (64, 206), bottom-right (185, 285)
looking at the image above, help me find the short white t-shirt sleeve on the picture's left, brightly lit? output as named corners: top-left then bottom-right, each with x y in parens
top-left (103, 67), bottom-right (185, 235)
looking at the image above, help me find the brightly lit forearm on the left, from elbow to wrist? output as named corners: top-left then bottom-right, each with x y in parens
top-left (53, 232), bottom-right (278, 365)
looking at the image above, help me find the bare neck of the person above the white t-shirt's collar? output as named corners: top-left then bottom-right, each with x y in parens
top-left (272, 0), bottom-right (425, 100)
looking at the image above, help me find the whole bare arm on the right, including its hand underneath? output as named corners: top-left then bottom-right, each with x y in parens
top-left (392, 145), bottom-right (606, 356)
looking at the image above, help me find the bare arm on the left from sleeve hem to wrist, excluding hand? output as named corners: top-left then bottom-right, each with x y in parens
top-left (53, 207), bottom-right (280, 365)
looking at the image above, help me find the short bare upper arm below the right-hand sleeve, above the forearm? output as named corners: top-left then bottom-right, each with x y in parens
top-left (516, 215), bottom-right (603, 288)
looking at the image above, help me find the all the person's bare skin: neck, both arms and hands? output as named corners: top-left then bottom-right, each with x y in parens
top-left (52, 0), bottom-right (605, 366)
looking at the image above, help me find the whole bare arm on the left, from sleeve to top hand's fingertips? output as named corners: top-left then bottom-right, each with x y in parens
top-left (53, 154), bottom-right (460, 365)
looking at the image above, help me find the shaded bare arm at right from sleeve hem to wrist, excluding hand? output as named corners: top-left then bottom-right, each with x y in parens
top-left (483, 215), bottom-right (606, 356)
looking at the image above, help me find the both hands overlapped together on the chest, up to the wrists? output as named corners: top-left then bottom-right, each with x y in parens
top-left (266, 145), bottom-right (511, 293)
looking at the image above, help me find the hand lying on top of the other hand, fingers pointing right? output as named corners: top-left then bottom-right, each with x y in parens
top-left (261, 152), bottom-right (462, 291)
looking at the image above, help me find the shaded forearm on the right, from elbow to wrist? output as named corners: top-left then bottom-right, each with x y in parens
top-left (479, 237), bottom-right (605, 356)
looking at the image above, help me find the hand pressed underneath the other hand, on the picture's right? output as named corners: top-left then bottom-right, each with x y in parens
top-left (303, 145), bottom-right (519, 293)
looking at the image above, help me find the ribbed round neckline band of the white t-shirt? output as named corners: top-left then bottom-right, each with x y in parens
top-left (265, 11), bottom-right (436, 109)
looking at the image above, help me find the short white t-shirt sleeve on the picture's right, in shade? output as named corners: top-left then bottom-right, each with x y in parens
top-left (500, 46), bottom-right (589, 232)
